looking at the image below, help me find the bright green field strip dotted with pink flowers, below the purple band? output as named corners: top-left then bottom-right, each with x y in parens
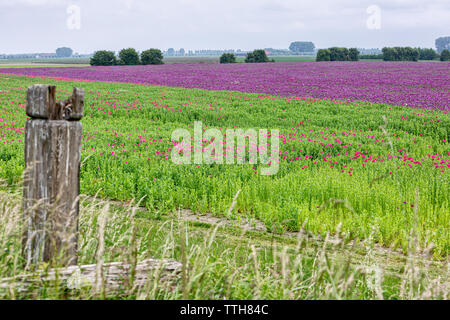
top-left (0, 75), bottom-right (450, 259)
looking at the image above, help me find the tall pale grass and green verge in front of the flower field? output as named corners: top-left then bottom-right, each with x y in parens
top-left (0, 192), bottom-right (449, 299)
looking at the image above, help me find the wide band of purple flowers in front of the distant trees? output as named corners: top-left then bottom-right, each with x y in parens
top-left (0, 62), bottom-right (450, 110)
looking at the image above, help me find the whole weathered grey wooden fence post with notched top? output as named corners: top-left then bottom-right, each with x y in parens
top-left (23, 85), bottom-right (84, 266)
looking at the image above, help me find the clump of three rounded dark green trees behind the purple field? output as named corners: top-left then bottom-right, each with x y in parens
top-left (90, 48), bottom-right (164, 66)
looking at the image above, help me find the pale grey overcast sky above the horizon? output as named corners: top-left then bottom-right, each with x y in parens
top-left (0, 0), bottom-right (450, 53)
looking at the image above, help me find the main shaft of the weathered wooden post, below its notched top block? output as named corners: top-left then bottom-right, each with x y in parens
top-left (24, 120), bottom-right (82, 265)
